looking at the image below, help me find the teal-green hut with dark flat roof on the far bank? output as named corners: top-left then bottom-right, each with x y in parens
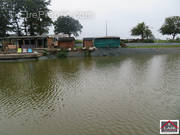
top-left (94, 37), bottom-right (120, 48)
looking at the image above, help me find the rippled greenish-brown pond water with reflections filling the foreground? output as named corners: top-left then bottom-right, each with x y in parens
top-left (0, 55), bottom-right (180, 135)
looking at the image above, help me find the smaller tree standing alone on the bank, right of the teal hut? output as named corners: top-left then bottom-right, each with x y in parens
top-left (131, 22), bottom-right (153, 40)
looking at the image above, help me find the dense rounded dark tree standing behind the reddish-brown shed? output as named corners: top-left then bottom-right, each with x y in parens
top-left (54, 16), bottom-right (83, 37)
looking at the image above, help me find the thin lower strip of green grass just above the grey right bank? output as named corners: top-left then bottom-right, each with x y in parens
top-left (128, 44), bottom-right (180, 48)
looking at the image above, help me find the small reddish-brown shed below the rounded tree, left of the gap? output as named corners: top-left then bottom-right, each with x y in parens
top-left (57, 37), bottom-right (75, 49)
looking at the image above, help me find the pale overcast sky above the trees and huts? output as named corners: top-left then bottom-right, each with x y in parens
top-left (50, 0), bottom-right (180, 39)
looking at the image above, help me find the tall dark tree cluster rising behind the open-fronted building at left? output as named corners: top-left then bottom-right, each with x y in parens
top-left (0, 0), bottom-right (53, 36)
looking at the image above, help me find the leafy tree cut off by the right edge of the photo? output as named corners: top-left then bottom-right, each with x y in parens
top-left (160, 16), bottom-right (180, 40)
